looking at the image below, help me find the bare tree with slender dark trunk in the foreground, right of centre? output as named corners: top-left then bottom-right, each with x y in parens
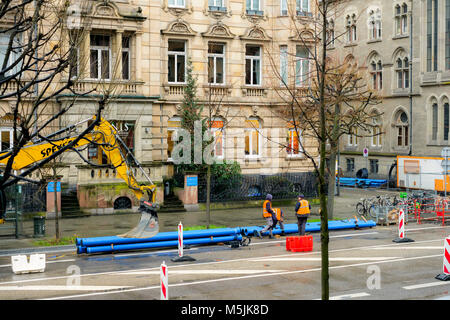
top-left (268, 0), bottom-right (381, 300)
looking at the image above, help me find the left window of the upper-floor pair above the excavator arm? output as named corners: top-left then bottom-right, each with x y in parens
top-left (90, 34), bottom-right (111, 79)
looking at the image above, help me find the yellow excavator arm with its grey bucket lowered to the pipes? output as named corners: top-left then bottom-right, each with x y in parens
top-left (0, 117), bottom-right (159, 238)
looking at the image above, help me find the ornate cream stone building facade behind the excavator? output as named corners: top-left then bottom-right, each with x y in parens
top-left (1, 0), bottom-right (322, 212)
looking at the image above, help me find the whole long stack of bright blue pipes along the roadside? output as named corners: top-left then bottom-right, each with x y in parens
top-left (76, 219), bottom-right (376, 254)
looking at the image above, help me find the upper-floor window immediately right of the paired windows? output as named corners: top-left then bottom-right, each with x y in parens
top-left (167, 40), bottom-right (186, 83)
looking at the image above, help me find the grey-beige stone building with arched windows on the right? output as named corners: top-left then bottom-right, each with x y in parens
top-left (333, 0), bottom-right (450, 184)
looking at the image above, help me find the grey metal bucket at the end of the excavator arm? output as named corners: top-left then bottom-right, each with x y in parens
top-left (118, 201), bottom-right (159, 239)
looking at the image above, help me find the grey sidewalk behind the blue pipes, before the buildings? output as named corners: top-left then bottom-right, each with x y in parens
top-left (0, 188), bottom-right (398, 255)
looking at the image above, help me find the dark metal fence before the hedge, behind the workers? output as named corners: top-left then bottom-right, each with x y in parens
top-left (198, 172), bottom-right (317, 202)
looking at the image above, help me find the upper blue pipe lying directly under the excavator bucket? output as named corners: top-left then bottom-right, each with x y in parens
top-left (77, 228), bottom-right (241, 247)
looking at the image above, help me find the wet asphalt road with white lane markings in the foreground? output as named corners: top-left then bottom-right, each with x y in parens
top-left (0, 223), bottom-right (450, 301)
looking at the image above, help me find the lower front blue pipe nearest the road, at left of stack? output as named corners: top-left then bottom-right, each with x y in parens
top-left (86, 234), bottom-right (242, 253)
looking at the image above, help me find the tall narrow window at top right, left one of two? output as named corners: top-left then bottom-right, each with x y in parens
top-left (426, 0), bottom-right (438, 72)
